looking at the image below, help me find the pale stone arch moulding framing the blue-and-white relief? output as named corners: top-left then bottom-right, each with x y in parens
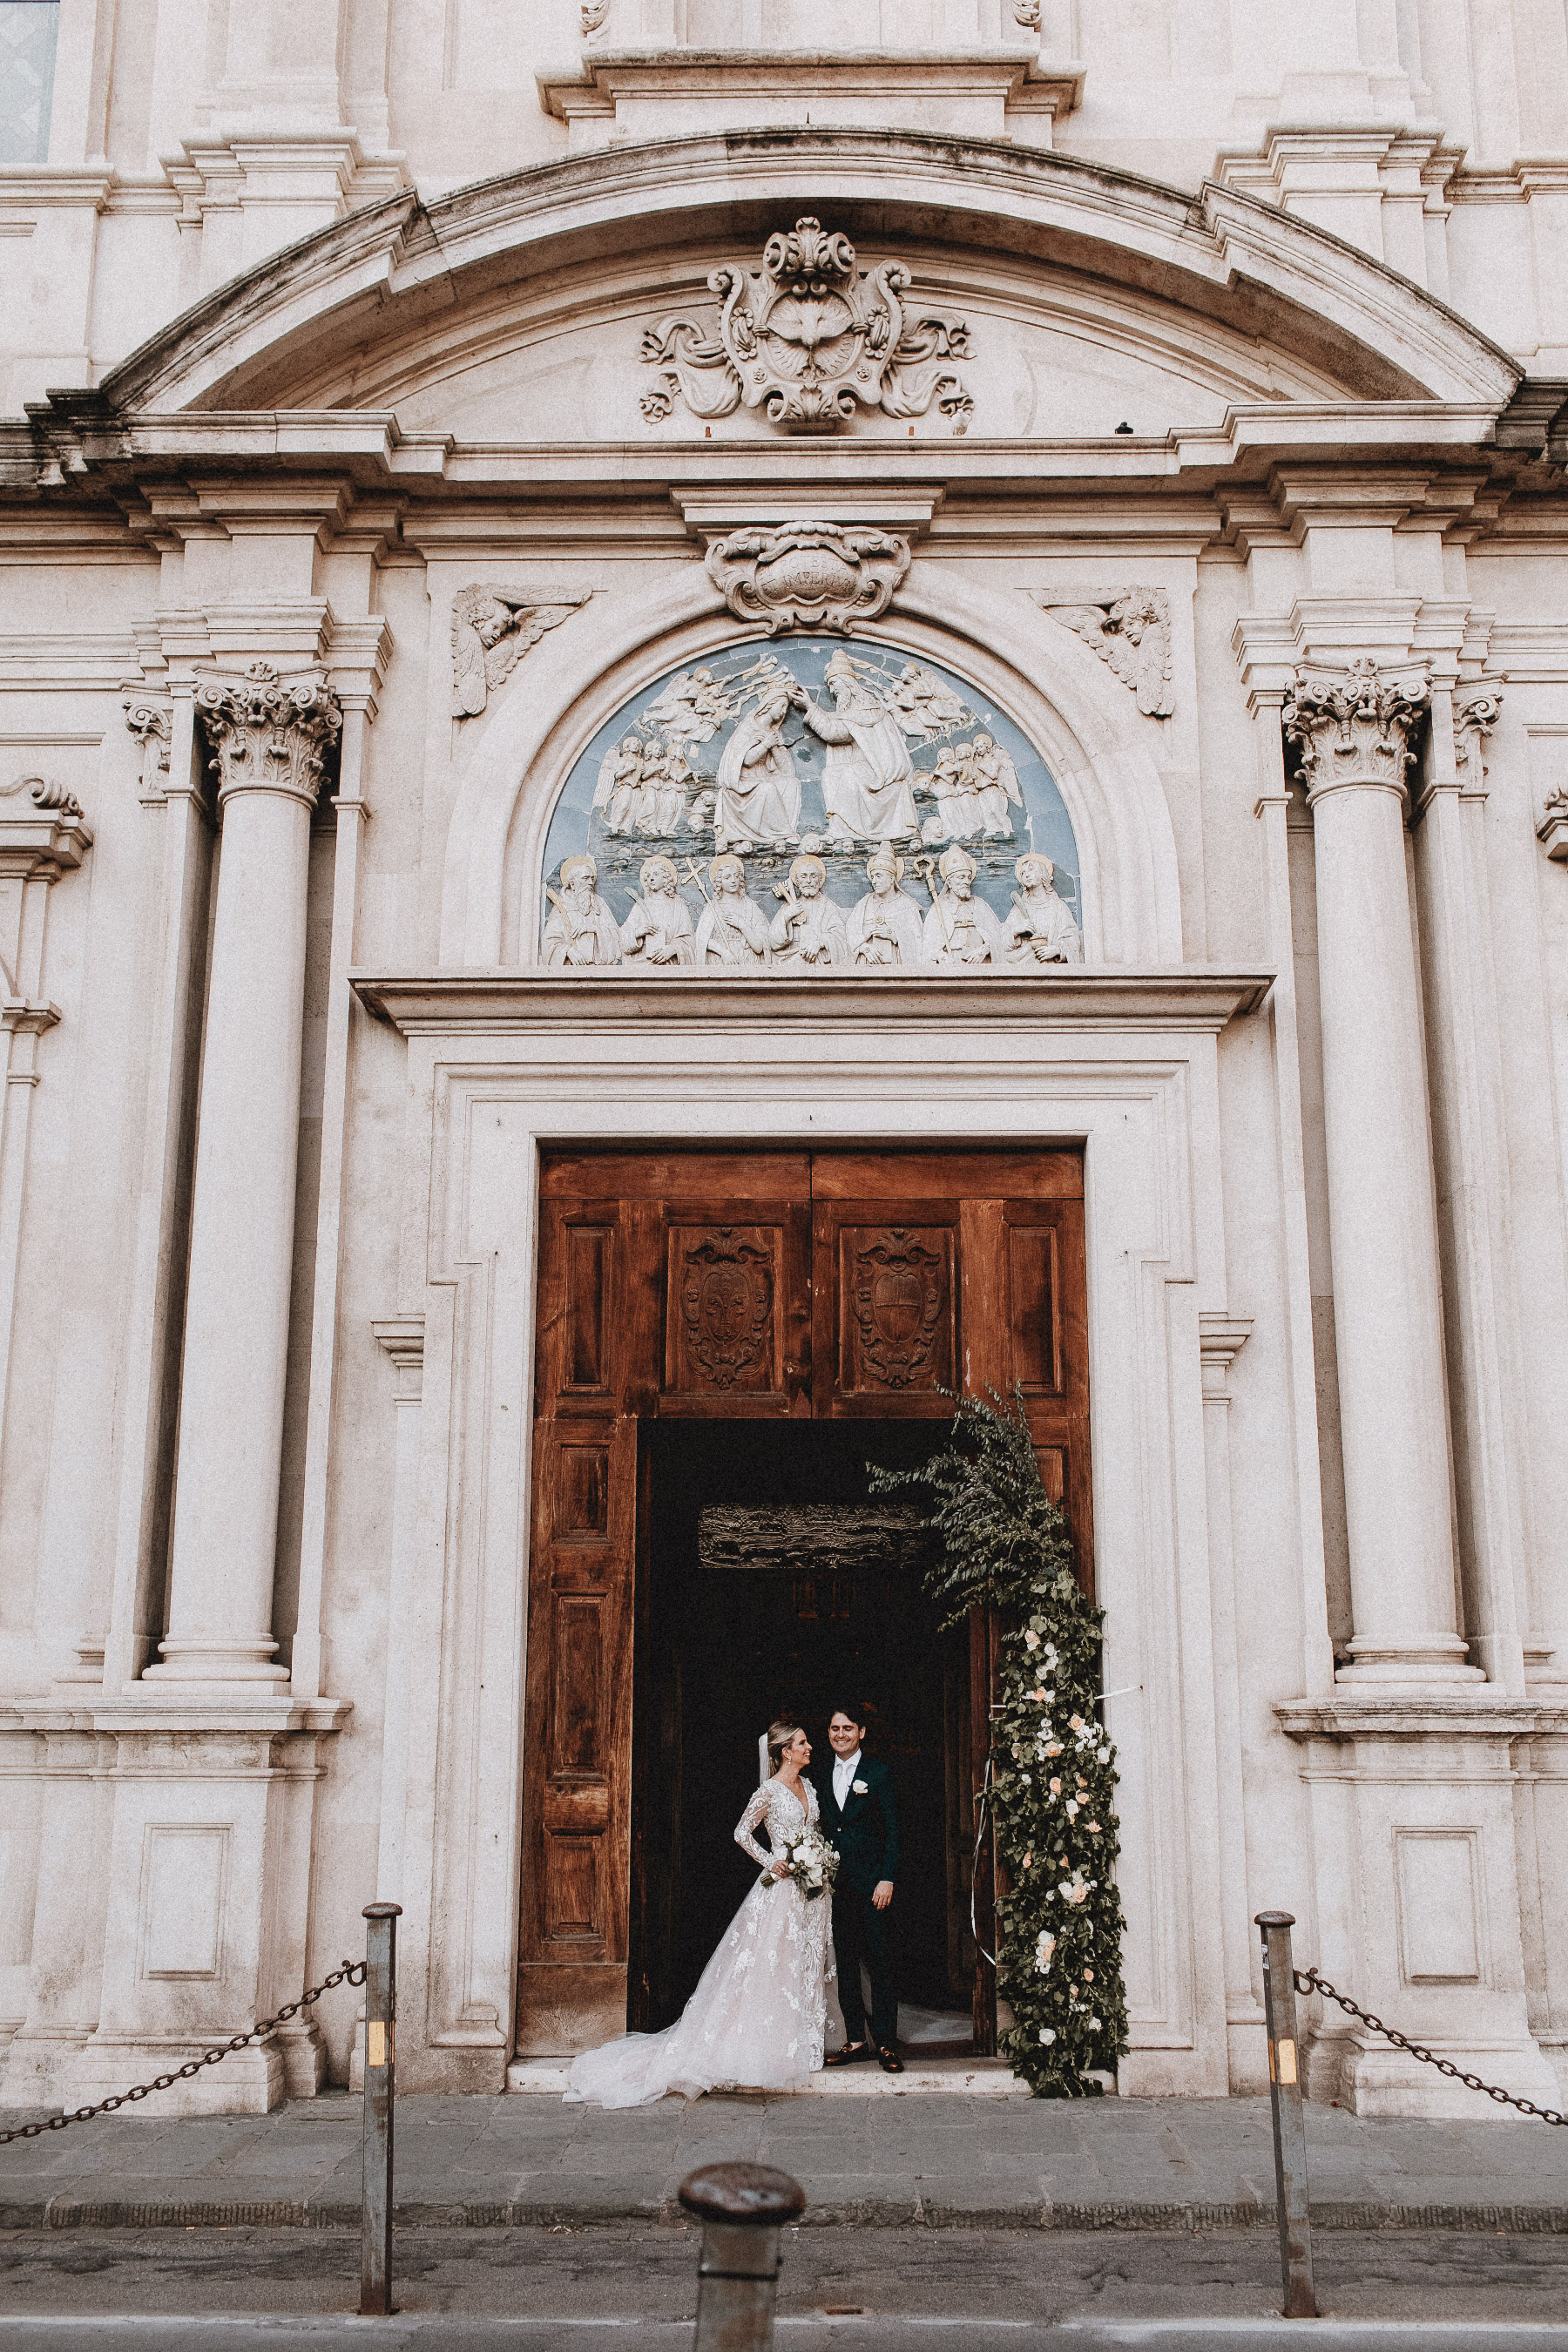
top-left (440, 560), bottom-right (1182, 969)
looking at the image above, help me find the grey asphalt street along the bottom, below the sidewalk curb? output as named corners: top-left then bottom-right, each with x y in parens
top-left (0, 2225), bottom-right (1568, 2352)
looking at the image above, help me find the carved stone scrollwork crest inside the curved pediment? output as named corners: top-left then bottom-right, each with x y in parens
top-left (642, 219), bottom-right (973, 433)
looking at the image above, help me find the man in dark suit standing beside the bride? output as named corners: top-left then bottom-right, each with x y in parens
top-left (821, 1706), bottom-right (902, 2074)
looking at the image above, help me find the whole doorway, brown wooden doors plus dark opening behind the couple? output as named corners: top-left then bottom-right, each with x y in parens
top-left (517, 1148), bottom-right (1093, 2060)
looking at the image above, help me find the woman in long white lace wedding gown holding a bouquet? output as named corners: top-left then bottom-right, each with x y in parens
top-left (566, 1724), bottom-right (832, 2107)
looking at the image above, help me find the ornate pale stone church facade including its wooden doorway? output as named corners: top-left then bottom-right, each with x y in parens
top-left (0, 0), bottom-right (1568, 2114)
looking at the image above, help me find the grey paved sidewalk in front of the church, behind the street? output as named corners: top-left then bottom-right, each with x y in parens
top-left (0, 2091), bottom-right (1568, 2234)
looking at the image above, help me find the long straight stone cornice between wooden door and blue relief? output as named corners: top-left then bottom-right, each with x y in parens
top-left (348, 964), bottom-right (1274, 1037)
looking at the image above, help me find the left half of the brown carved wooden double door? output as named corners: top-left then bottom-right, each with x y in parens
top-left (517, 1152), bottom-right (811, 2053)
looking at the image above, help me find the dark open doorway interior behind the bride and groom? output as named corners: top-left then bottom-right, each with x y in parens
top-left (628, 1421), bottom-right (973, 2030)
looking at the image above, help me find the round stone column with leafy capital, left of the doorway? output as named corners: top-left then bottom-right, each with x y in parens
top-left (148, 663), bottom-right (341, 1686)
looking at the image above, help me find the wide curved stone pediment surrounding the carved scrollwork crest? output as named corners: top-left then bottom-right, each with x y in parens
top-left (101, 130), bottom-right (1518, 423)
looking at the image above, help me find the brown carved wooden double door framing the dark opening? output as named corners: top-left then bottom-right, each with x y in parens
top-left (517, 1150), bottom-right (1093, 2053)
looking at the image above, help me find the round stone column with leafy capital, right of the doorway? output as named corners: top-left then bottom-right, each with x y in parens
top-left (1283, 661), bottom-right (1478, 1686)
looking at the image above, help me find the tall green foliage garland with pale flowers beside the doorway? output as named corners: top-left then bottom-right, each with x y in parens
top-left (870, 1397), bottom-right (1126, 2098)
